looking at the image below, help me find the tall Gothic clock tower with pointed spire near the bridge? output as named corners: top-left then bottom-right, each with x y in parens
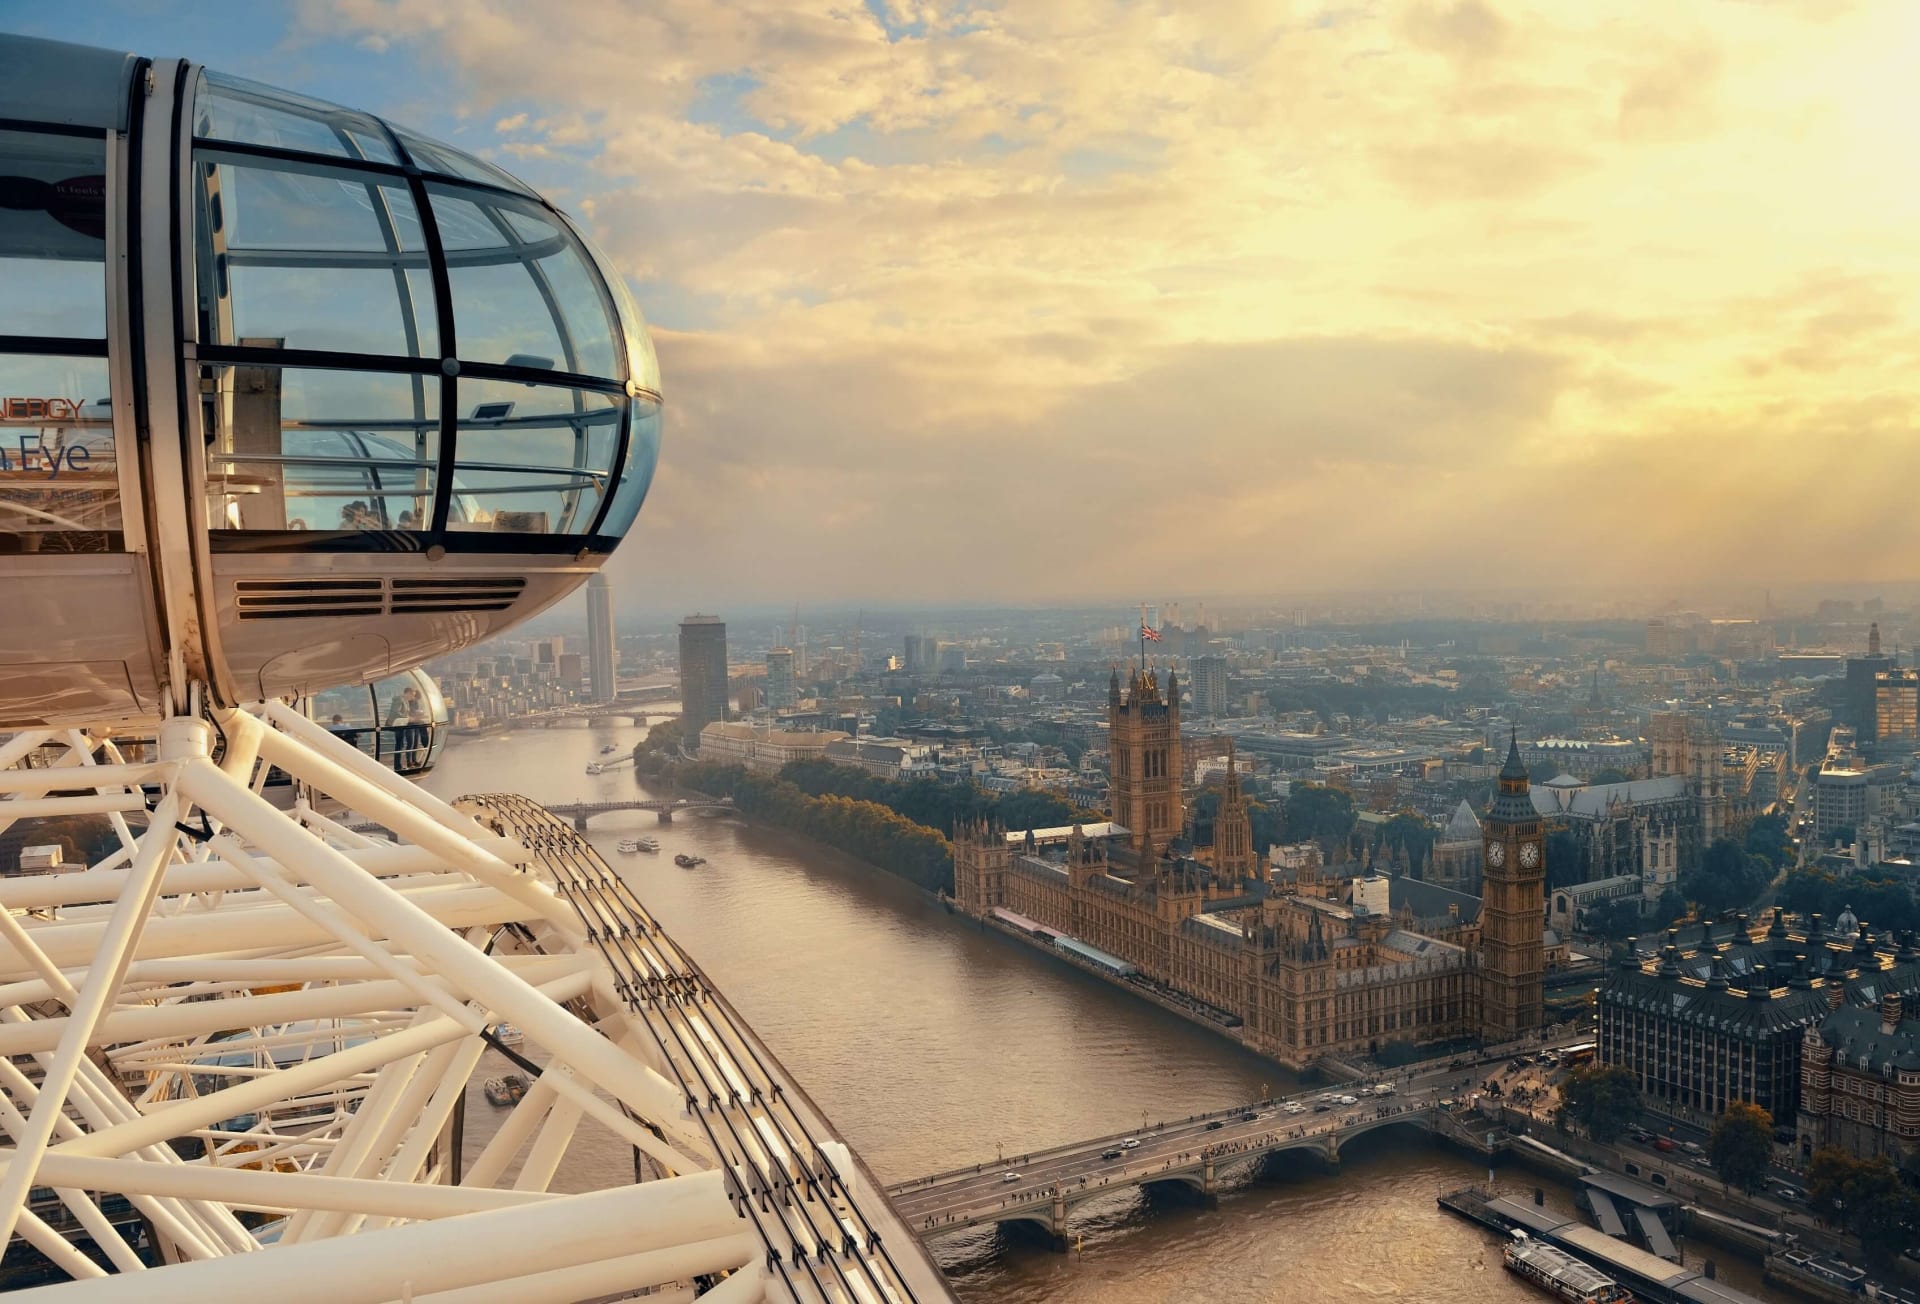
top-left (1480, 736), bottom-right (1548, 1043)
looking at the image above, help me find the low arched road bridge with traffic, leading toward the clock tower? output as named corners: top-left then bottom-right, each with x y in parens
top-left (887, 1070), bottom-right (1500, 1250)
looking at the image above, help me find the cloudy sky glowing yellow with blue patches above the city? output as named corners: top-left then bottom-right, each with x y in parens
top-left (18, 0), bottom-right (1920, 609)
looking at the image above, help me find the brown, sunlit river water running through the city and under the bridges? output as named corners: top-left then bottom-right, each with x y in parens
top-left (422, 722), bottom-right (1782, 1304)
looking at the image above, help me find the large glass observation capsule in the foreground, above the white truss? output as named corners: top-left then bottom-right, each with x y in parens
top-left (0, 36), bottom-right (660, 728)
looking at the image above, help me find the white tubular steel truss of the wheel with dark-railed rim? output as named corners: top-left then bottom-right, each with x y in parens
top-left (0, 703), bottom-right (950, 1304)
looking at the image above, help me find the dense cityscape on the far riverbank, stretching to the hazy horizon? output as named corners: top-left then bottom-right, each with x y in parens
top-left (412, 597), bottom-right (1920, 1298)
